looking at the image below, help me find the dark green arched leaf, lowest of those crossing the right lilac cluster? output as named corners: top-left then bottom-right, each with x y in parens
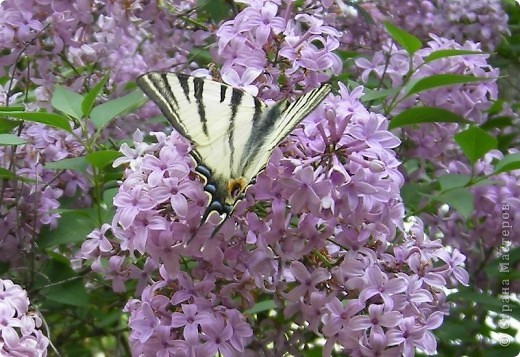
top-left (388, 107), bottom-right (471, 129)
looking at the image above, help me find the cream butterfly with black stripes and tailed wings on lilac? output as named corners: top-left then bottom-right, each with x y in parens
top-left (137, 72), bottom-right (331, 236)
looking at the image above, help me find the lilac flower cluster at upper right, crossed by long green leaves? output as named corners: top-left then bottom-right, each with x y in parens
top-left (356, 35), bottom-right (499, 161)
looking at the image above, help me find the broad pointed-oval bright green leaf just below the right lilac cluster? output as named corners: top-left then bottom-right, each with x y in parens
top-left (454, 126), bottom-right (498, 164)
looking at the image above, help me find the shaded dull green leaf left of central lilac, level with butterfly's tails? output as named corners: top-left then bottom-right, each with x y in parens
top-left (38, 210), bottom-right (98, 248)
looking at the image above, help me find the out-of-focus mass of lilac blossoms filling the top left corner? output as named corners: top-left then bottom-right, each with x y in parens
top-left (0, 0), bottom-right (209, 101)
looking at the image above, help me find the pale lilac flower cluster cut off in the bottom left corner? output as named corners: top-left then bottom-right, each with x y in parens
top-left (0, 279), bottom-right (49, 357)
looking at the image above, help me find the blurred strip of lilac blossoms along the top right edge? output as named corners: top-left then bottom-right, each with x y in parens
top-left (331, 0), bottom-right (509, 51)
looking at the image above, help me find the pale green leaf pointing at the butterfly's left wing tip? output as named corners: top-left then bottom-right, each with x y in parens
top-left (90, 90), bottom-right (146, 129)
